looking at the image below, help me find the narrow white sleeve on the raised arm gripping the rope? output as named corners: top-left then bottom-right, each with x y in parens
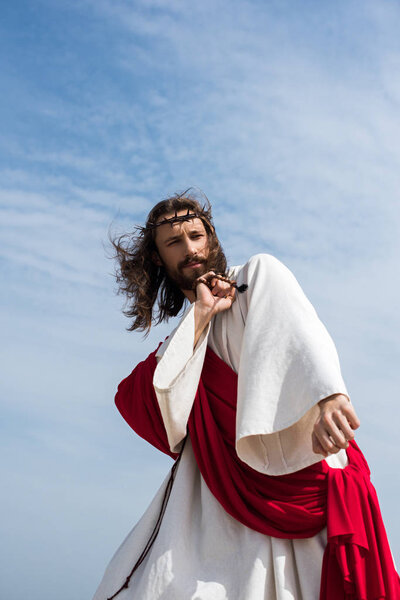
top-left (153, 303), bottom-right (210, 452)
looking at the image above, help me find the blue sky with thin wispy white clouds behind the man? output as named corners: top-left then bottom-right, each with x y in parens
top-left (0, 0), bottom-right (400, 600)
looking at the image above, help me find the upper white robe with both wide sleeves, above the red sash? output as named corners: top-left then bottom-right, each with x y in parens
top-left (153, 254), bottom-right (349, 475)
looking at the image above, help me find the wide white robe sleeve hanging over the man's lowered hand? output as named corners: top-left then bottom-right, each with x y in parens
top-left (236, 254), bottom-right (350, 475)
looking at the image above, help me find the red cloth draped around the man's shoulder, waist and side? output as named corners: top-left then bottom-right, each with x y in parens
top-left (115, 348), bottom-right (400, 600)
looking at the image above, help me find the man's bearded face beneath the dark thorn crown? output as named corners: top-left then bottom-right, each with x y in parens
top-left (155, 209), bottom-right (210, 290)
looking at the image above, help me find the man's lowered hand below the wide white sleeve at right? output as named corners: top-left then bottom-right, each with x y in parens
top-left (312, 394), bottom-right (360, 456)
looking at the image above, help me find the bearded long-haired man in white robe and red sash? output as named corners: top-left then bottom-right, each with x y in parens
top-left (94, 193), bottom-right (400, 600)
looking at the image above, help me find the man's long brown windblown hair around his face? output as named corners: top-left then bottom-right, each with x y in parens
top-left (108, 188), bottom-right (227, 335)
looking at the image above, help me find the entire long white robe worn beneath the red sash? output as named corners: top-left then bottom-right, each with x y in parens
top-left (93, 254), bottom-right (349, 600)
